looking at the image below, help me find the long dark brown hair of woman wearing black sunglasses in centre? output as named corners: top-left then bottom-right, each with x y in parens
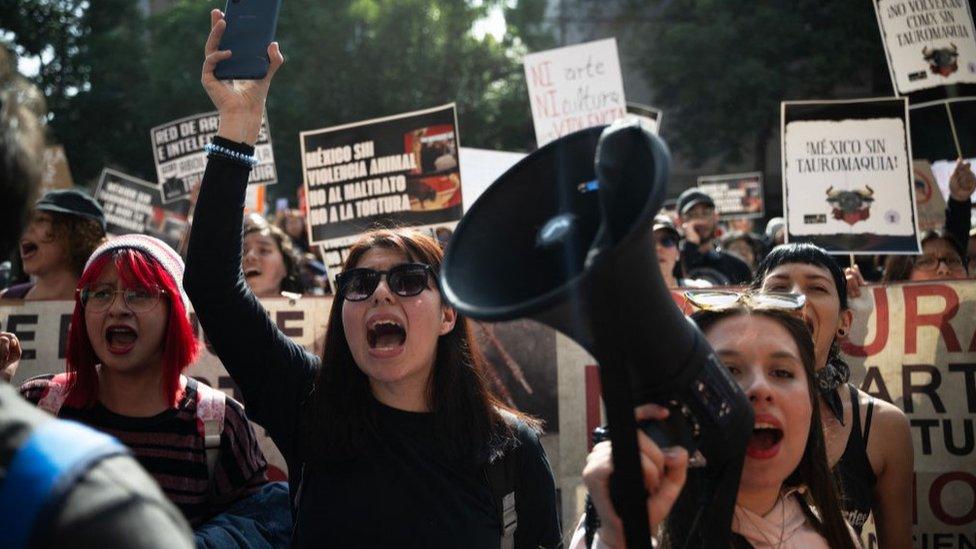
top-left (305, 229), bottom-right (540, 464)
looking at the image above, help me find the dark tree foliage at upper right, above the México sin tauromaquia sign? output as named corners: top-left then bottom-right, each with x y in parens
top-left (620, 0), bottom-right (892, 169)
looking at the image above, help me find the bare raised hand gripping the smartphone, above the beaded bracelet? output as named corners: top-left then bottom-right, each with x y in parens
top-left (200, 9), bottom-right (285, 145)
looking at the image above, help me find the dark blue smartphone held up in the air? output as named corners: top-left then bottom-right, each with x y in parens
top-left (214, 0), bottom-right (281, 80)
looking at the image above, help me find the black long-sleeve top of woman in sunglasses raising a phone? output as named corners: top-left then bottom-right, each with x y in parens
top-left (183, 138), bottom-right (561, 549)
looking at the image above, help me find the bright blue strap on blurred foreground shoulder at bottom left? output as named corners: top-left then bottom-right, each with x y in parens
top-left (0, 420), bottom-right (128, 548)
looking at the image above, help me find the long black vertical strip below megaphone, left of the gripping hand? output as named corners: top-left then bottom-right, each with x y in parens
top-left (599, 356), bottom-right (651, 549)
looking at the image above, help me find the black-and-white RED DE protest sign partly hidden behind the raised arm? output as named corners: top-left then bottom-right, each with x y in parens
top-left (149, 112), bottom-right (278, 201)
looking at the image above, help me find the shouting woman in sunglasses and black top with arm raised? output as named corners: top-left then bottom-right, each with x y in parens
top-left (184, 10), bottom-right (561, 548)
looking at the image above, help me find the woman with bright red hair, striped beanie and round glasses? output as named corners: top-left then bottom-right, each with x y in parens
top-left (21, 235), bottom-right (267, 526)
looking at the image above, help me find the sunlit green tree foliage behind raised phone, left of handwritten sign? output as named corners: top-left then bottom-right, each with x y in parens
top-left (0, 0), bottom-right (551, 201)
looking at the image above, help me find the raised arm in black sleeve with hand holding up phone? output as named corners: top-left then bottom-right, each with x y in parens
top-left (183, 10), bottom-right (318, 462)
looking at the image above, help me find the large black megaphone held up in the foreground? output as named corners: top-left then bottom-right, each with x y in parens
top-left (440, 120), bottom-right (753, 547)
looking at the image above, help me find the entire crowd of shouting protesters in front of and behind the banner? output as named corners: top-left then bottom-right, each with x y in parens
top-left (0, 10), bottom-right (976, 548)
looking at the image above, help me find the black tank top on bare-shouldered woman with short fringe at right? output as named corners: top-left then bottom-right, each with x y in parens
top-left (834, 383), bottom-right (878, 535)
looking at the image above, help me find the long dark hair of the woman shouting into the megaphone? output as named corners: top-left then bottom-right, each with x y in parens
top-left (691, 308), bottom-right (855, 549)
